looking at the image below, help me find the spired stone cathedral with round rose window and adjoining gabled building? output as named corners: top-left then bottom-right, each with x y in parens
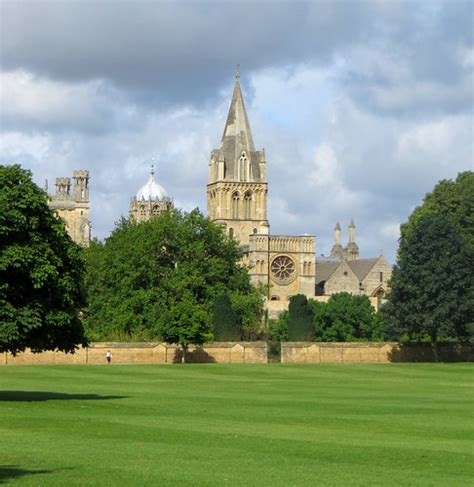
top-left (207, 72), bottom-right (391, 317)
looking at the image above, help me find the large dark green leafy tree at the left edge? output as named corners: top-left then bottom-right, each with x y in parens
top-left (0, 165), bottom-right (87, 354)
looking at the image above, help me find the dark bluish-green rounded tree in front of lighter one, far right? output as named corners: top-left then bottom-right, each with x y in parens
top-left (384, 211), bottom-right (474, 357)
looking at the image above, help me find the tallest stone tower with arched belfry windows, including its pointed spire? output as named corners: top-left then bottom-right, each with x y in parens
top-left (207, 74), bottom-right (269, 246)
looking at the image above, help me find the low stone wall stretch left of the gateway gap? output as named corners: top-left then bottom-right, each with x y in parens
top-left (0, 342), bottom-right (267, 365)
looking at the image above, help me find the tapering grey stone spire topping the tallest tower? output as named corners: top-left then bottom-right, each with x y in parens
top-left (219, 72), bottom-right (264, 181)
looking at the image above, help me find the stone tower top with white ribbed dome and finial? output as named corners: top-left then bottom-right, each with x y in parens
top-left (129, 166), bottom-right (173, 222)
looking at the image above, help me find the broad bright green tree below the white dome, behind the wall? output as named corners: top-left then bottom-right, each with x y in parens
top-left (86, 210), bottom-right (262, 350)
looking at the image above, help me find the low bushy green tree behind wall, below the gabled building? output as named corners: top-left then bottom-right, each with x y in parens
top-left (310, 293), bottom-right (382, 342)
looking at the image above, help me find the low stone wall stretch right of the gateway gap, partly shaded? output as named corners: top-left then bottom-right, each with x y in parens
top-left (281, 342), bottom-right (474, 364)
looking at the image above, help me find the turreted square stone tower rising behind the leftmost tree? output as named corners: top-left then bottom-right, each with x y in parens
top-left (49, 170), bottom-right (91, 246)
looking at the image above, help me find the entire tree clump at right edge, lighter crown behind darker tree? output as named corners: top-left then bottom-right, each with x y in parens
top-left (383, 171), bottom-right (474, 352)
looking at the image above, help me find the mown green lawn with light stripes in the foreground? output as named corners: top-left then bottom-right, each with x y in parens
top-left (0, 364), bottom-right (474, 487)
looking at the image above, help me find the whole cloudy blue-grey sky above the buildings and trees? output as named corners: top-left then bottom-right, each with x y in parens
top-left (0, 0), bottom-right (474, 263)
